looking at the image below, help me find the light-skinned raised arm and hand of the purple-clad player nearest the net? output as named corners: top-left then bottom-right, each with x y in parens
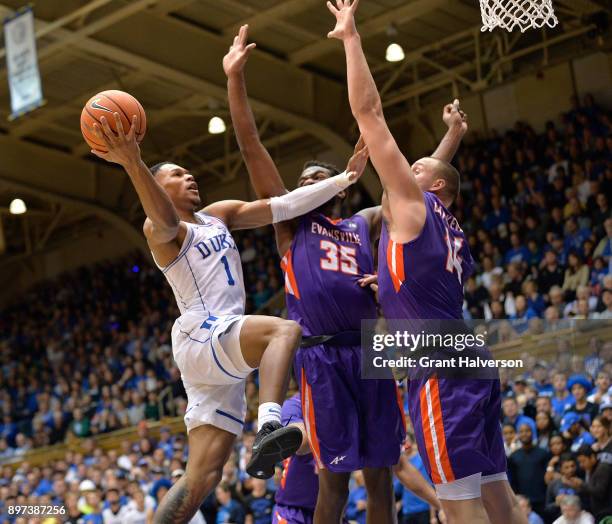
top-left (327, 0), bottom-right (423, 201)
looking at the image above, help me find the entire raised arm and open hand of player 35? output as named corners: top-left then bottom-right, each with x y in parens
top-left (223, 25), bottom-right (287, 198)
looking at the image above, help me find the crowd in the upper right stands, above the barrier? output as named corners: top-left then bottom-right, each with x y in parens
top-left (454, 96), bottom-right (612, 332)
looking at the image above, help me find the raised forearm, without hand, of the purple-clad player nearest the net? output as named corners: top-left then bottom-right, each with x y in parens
top-left (344, 33), bottom-right (382, 121)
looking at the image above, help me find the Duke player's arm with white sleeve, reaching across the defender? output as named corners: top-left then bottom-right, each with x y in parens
top-left (204, 148), bottom-right (368, 229)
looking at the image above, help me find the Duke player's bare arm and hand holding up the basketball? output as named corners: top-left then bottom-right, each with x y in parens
top-left (92, 113), bottom-right (180, 244)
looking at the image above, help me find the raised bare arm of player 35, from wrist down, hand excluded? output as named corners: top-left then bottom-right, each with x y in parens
top-left (227, 75), bottom-right (287, 198)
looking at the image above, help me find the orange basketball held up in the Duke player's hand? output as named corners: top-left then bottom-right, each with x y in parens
top-left (81, 89), bottom-right (147, 152)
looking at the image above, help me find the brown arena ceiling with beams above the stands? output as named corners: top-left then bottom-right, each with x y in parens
top-left (0, 0), bottom-right (612, 268)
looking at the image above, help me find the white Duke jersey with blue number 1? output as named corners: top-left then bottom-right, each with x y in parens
top-left (153, 212), bottom-right (246, 317)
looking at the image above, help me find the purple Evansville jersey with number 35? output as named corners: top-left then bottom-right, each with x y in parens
top-left (281, 212), bottom-right (377, 336)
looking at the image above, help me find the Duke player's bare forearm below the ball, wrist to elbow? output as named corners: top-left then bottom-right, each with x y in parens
top-left (124, 158), bottom-right (180, 229)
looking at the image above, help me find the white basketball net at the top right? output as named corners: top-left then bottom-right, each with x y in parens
top-left (480, 0), bottom-right (559, 33)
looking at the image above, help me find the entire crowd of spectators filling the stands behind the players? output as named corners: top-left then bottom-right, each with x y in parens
top-left (0, 92), bottom-right (612, 524)
